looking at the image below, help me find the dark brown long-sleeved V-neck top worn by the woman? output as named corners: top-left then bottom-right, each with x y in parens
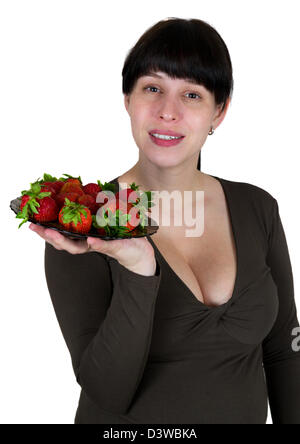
top-left (45, 176), bottom-right (300, 424)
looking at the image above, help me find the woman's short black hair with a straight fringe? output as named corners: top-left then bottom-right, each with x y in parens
top-left (122, 17), bottom-right (233, 170)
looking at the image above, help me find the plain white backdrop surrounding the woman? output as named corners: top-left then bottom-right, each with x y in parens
top-left (0, 0), bottom-right (300, 424)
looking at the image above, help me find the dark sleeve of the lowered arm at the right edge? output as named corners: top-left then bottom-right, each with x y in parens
top-left (263, 199), bottom-right (300, 424)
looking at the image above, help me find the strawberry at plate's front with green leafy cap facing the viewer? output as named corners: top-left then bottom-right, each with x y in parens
top-left (58, 198), bottom-right (92, 234)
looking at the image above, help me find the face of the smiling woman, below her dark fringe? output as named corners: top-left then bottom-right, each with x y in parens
top-left (124, 72), bottom-right (229, 167)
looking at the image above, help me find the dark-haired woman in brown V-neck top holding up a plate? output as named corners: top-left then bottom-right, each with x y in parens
top-left (29, 18), bottom-right (300, 424)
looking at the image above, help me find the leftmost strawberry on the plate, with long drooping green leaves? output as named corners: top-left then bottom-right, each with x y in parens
top-left (16, 181), bottom-right (58, 228)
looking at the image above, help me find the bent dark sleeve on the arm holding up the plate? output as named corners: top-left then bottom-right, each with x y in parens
top-left (45, 242), bottom-right (161, 414)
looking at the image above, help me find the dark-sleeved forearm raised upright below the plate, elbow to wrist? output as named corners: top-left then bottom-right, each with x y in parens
top-left (76, 262), bottom-right (159, 414)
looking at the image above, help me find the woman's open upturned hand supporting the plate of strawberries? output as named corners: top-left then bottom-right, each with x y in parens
top-left (29, 223), bottom-right (156, 276)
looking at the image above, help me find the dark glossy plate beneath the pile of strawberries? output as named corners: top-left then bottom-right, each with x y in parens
top-left (10, 196), bottom-right (159, 240)
